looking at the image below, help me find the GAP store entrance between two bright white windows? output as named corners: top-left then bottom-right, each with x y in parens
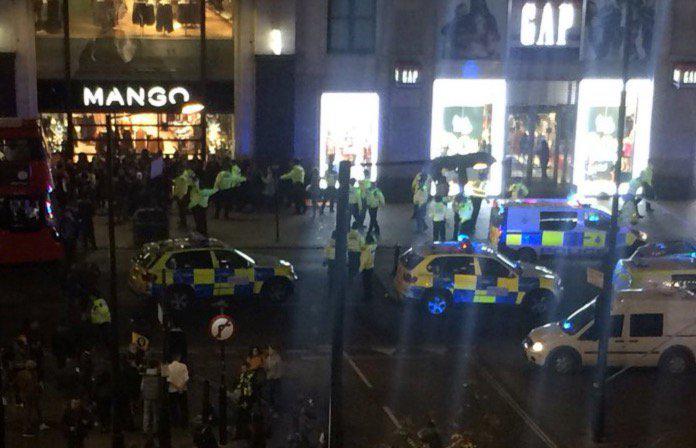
top-left (504, 106), bottom-right (575, 185)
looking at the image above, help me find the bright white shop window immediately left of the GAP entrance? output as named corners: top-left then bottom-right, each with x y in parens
top-left (430, 79), bottom-right (506, 194)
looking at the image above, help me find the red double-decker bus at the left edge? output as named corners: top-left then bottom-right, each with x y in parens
top-left (0, 118), bottom-right (64, 264)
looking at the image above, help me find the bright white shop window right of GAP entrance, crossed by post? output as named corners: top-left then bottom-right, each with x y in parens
top-left (573, 79), bottom-right (653, 195)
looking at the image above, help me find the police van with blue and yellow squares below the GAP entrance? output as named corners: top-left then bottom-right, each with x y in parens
top-left (488, 199), bottom-right (647, 262)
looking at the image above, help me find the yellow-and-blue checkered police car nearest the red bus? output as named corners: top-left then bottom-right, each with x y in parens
top-left (128, 238), bottom-right (297, 310)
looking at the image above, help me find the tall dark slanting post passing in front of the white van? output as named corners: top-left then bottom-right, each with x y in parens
top-left (592, 0), bottom-right (633, 442)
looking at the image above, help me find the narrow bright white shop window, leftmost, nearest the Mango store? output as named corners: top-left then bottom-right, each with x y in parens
top-left (319, 92), bottom-right (379, 180)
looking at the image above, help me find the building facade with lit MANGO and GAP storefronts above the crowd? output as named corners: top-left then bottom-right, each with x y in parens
top-left (0, 0), bottom-right (696, 197)
